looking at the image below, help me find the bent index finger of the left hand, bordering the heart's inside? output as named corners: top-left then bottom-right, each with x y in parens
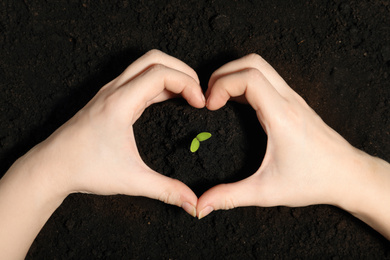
top-left (117, 65), bottom-right (205, 122)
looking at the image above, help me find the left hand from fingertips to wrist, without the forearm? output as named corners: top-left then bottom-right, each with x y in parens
top-left (29, 50), bottom-right (205, 216)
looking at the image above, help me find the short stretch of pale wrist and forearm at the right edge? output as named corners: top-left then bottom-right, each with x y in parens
top-left (341, 152), bottom-right (390, 240)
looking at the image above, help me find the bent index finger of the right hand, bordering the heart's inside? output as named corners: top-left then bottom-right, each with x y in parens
top-left (207, 68), bottom-right (286, 125)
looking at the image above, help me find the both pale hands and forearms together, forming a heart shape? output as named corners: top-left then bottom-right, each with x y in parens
top-left (0, 50), bottom-right (390, 259)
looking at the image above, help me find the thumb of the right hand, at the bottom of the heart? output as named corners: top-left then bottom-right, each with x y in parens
top-left (197, 175), bottom-right (260, 219)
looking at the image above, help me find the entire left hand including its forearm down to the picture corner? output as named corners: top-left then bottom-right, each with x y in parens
top-left (0, 50), bottom-right (205, 259)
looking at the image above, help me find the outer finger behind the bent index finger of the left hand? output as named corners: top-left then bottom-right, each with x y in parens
top-left (116, 50), bottom-right (199, 85)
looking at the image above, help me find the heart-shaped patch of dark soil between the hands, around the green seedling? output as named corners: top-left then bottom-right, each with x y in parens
top-left (134, 99), bottom-right (267, 196)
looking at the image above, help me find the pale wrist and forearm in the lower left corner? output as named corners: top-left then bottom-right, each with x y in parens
top-left (0, 145), bottom-right (65, 259)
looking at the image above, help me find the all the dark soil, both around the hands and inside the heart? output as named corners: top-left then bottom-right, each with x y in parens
top-left (0, 0), bottom-right (390, 259)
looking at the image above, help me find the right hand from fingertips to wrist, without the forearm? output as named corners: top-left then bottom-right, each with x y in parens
top-left (197, 54), bottom-right (365, 218)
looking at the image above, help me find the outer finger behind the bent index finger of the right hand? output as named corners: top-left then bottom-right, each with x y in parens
top-left (206, 54), bottom-right (292, 97)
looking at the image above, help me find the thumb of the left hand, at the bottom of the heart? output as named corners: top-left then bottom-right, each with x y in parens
top-left (132, 170), bottom-right (198, 217)
